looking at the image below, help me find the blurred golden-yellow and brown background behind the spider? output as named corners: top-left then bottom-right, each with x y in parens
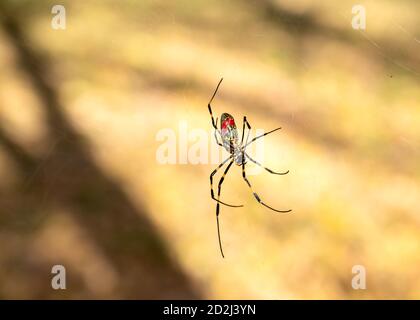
top-left (0, 0), bottom-right (420, 299)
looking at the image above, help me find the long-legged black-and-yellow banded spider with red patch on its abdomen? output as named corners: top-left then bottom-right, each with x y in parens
top-left (208, 78), bottom-right (292, 258)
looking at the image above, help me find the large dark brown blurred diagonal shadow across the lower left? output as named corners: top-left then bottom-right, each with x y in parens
top-left (0, 5), bottom-right (200, 299)
